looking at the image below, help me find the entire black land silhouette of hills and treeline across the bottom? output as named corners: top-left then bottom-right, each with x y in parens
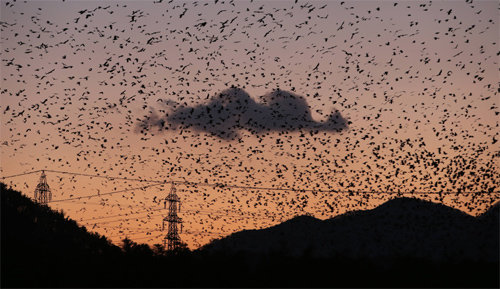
top-left (0, 183), bottom-right (499, 288)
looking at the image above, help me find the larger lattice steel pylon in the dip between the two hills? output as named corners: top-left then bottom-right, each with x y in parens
top-left (162, 182), bottom-right (182, 251)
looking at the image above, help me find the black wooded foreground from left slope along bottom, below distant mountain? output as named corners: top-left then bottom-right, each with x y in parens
top-left (0, 183), bottom-right (499, 288)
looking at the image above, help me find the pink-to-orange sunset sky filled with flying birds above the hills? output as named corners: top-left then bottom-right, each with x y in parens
top-left (0, 0), bottom-right (500, 249)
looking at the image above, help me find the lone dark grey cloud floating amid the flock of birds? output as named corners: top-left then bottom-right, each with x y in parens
top-left (140, 87), bottom-right (348, 140)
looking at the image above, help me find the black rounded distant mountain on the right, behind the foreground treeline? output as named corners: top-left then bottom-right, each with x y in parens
top-left (201, 198), bottom-right (499, 263)
